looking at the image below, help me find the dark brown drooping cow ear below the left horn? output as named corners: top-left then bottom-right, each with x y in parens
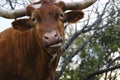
top-left (12, 19), bottom-right (32, 31)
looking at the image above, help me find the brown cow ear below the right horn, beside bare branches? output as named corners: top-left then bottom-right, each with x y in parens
top-left (64, 10), bottom-right (84, 23)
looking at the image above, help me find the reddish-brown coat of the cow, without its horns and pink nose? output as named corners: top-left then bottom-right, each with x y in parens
top-left (0, 0), bottom-right (83, 80)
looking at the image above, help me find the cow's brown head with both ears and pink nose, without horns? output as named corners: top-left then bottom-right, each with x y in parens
top-left (12, 2), bottom-right (84, 53)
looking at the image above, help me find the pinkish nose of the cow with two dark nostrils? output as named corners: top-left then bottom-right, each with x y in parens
top-left (43, 30), bottom-right (62, 47)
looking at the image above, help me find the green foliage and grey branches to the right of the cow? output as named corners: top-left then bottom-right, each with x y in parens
top-left (56, 1), bottom-right (120, 80)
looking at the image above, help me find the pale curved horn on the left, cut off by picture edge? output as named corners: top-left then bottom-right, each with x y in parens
top-left (0, 7), bottom-right (27, 19)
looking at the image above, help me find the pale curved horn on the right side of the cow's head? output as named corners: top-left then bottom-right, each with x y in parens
top-left (65, 0), bottom-right (97, 10)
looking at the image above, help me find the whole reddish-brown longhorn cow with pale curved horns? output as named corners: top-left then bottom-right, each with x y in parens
top-left (0, 0), bottom-right (96, 80)
